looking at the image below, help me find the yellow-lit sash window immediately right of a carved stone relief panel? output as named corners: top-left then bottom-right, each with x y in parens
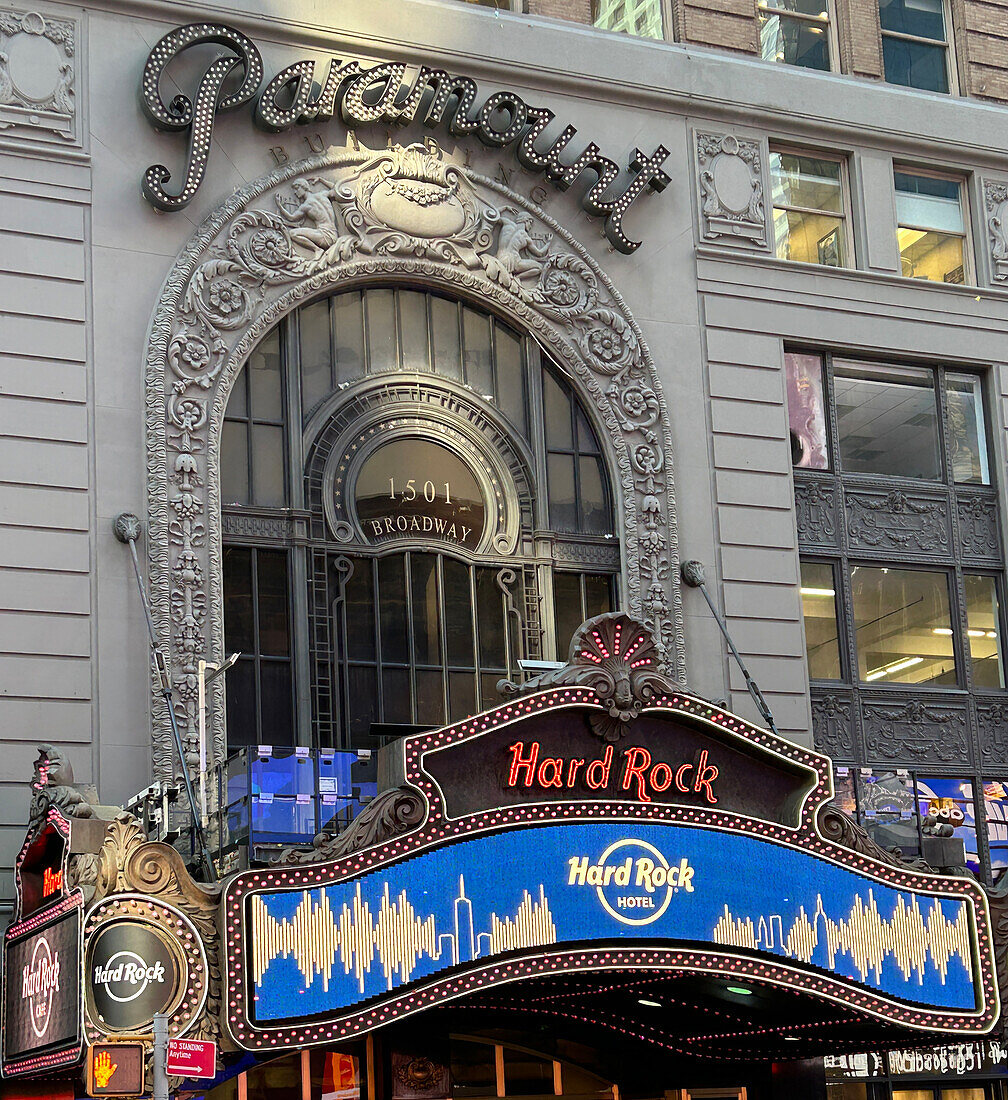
top-left (770, 147), bottom-right (851, 267)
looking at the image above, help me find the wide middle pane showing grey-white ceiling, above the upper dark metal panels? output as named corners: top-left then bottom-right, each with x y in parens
top-left (834, 362), bottom-right (942, 481)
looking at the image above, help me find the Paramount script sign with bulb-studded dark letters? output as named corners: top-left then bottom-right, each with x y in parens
top-left (133, 23), bottom-right (670, 253)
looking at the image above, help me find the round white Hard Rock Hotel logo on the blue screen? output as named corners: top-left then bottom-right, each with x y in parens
top-left (567, 839), bottom-right (694, 925)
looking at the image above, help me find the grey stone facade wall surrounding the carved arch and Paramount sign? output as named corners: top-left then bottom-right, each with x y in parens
top-left (0, 0), bottom-right (1008, 915)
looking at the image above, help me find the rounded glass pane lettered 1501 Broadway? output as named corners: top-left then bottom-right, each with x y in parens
top-left (353, 437), bottom-right (486, 550)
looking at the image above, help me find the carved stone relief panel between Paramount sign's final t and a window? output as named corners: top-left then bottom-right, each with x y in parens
top-left (697, 133), bottom-right (768, 249)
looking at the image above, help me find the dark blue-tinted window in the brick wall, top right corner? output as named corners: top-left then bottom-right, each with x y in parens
top-left (878, 0), bottom-right (952, 92)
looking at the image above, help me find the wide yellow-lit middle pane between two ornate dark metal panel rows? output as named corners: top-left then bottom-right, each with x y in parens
top-left (851, 565), bottom-right (956, 686)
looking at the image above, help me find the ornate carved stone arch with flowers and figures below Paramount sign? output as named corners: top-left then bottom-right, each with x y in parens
top-left (145, 139), bottom-right (686, 777)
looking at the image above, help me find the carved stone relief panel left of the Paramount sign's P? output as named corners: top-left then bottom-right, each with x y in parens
top-left (0, 10), bottom-right (77, 142)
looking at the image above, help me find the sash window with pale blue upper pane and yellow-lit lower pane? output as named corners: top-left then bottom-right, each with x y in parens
top-left (894, 167), bottom-right (973, 283)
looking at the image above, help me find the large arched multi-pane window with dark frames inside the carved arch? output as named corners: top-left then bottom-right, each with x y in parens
top-left (220, 287), bottom-right (620, 748)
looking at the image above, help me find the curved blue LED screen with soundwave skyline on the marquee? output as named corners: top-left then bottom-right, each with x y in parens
top-left (245, 822), bottom-right (978, 1023)
